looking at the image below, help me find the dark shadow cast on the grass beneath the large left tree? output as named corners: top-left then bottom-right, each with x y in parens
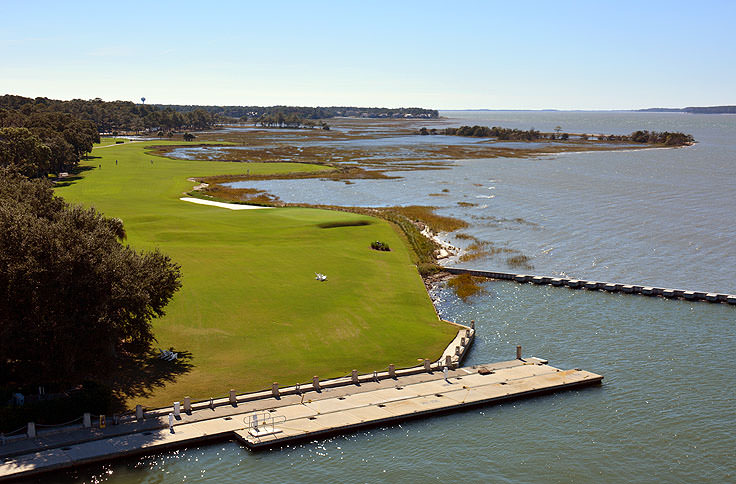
top-left (111, 350), bottom-right (194, 411)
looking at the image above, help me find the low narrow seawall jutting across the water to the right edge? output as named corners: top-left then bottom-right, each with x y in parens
top-left (444, 267), bottom-right (736, 305)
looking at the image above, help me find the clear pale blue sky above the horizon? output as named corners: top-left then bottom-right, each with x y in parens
top-left (0, 0), bottom-right (736, 109)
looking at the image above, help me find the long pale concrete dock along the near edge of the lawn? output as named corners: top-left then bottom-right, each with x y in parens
top-left (0, 358), bottom-right (603, 480)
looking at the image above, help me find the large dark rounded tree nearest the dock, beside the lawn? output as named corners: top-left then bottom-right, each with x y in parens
top-left (0, 168), bottom-right (180, 389)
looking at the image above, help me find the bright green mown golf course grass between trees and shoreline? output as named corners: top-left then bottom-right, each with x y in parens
top-left (57, 141), bottom-right (456, 406)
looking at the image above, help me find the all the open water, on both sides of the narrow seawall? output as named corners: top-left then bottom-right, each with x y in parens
top-left (53, 112), bottom-right (736, 483)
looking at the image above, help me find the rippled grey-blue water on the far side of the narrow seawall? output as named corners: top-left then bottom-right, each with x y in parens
top-left (224, 112), bottom-right (736, 292)
